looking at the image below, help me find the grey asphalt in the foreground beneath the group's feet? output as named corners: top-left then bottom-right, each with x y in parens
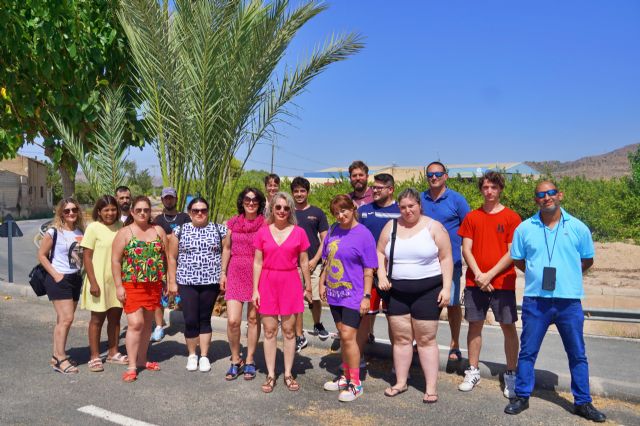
top-left (0, 297), bottom-right (640, 425)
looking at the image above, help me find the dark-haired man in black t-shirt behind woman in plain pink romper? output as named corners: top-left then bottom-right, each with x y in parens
top-left (291, 177), bottom-right (329, 352)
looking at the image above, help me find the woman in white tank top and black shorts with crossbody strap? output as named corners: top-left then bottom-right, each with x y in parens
top-left (378, 188), bottom-right (453, 403)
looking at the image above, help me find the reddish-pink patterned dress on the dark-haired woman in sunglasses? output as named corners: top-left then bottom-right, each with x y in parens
top-left (224, 215), bottom-right (265, 302)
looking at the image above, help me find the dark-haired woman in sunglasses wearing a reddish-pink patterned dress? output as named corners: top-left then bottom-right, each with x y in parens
top-left (220, 187), bottom-right (265, 380)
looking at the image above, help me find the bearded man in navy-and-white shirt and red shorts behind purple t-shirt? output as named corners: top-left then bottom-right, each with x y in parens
top-left (357, 173), bottom-right (400, 353)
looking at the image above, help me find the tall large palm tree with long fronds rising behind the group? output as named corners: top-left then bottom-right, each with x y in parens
top-left (118, 0), bottom-right (363, 217)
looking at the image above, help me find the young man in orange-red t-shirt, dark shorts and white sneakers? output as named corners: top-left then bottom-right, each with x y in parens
top-left (458, 171), bottom-right (521, 398)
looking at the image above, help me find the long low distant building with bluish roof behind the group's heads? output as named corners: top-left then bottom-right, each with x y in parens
top-left (303, 162), bottom-right (540, 184)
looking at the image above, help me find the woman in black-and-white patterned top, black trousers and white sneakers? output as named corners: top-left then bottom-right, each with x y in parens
top-left (167, 197), bottom-right (227, 373)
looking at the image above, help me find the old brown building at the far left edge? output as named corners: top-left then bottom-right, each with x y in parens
top-left (0, 155), bottom-right (53, 218)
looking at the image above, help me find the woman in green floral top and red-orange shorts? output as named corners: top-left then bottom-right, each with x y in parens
top-left (111, 196), bottom-right (167, 382)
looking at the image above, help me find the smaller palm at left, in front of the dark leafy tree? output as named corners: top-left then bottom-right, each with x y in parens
top-left (51, 87), bottom-right (128, 199)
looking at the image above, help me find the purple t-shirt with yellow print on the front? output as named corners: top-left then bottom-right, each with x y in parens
top-left (322, 224), bottom-right (378, 310)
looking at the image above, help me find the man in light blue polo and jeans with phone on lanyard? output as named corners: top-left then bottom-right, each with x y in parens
top-left (504, 181), bottom-right (606, 422)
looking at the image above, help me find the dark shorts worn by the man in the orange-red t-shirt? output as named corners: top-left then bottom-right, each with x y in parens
top-left (464, 287), bottom-right (518, 324)
